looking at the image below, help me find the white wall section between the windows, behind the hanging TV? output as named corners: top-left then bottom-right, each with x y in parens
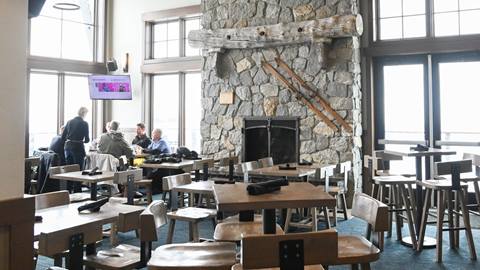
top-left (108, 0), bottom-right (200, 139)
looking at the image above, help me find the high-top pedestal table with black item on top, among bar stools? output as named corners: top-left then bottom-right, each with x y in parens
top-left (384, 148), bottom-right (457, 247)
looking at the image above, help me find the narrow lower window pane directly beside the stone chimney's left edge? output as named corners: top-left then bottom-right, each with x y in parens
top-left (185, 73), bottom-right (202, 153)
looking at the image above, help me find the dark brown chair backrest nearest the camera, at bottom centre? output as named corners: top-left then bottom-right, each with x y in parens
top-left (241, 229), bottom-right (338, 269)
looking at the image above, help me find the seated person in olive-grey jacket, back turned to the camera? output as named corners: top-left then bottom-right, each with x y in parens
top-left (97, 121), bottom-right (133, 159)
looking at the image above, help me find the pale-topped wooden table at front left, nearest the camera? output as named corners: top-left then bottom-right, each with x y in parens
top-left (34, 201), bottom-right (144, 270)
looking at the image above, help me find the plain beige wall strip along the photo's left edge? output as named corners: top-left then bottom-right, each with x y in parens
top-left (0, 0), bottom-right (28, 201)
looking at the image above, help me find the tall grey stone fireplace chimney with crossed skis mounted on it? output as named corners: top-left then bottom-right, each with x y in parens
top-left (201, 0), bottom-right (362, 190)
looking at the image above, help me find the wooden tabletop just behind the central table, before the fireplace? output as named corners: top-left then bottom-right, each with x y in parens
top-left (248, 164), bottom-right (317, 182)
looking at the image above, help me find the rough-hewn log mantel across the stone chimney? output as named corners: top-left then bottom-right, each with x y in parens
top-left (188, 14), bottom-right (363, 52)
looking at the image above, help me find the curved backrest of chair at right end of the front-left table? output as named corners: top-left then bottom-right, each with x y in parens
top-left (140, 201), bottom-right (168, 242)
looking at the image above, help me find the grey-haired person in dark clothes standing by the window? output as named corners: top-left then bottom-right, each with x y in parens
top-left (62, 107), bottom-right (90, 192)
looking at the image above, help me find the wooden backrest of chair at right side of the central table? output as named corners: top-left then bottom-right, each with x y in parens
top-left (352, 192), bottom-right (388, 232)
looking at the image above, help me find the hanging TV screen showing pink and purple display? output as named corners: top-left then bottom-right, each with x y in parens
top-left (88, 75), bottom-right (132, 99)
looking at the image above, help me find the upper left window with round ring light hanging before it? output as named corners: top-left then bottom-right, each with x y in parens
top-left (30, 0), bottom-right (105, 62)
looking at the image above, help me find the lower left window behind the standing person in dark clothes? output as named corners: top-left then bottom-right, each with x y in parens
top-left (28, 71), bottom-right (95, 155)
